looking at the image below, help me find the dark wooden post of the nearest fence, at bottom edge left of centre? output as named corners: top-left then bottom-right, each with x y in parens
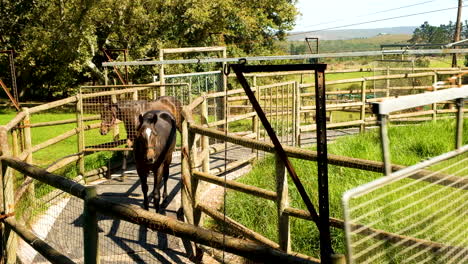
top-left (83, 186), bottom-right (100, 264)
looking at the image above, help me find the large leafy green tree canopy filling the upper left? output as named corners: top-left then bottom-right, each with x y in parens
top-left (0, 0), bottom-right (298, 99)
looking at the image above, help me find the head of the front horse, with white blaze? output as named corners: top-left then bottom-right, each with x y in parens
top-left (135, 110), bottom-right (176, 166)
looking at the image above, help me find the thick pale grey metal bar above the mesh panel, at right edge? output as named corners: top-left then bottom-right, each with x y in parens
top-left (372, 85), bottom-right (468, 115)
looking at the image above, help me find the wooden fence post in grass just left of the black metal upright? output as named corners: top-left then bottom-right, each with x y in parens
top-left (275, 155), bottom-right (291, 253)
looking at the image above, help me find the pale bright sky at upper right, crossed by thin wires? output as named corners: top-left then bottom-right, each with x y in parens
top-left (293, 0), bottom-right (468, 31)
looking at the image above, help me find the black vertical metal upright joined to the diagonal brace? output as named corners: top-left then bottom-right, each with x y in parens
top-left (315, 70), bottom-right (333, 263)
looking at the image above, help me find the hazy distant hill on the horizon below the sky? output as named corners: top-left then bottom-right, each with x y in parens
top-left (288, 27), bottom-right (416, 41)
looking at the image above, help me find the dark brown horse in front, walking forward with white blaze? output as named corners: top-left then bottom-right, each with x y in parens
top-left (133, 108), bottom-right (176, 212)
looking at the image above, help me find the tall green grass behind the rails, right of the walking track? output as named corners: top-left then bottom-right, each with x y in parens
top-left (214, 120), bottom-right (468, 257)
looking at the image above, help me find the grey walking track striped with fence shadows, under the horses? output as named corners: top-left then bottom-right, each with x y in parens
top-left (18, 128), bottom-right (359, 264)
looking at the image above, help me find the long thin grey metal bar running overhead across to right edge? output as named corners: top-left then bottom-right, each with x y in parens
top-left (102, 49), bottom-right (468, 67)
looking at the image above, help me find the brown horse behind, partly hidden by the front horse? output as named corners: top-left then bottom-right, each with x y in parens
top-left (100, 96), bottom-right (182, 147)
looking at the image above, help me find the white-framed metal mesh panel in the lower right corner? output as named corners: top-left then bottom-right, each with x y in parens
top-left (343, 148), bottom-right (468, 263)
